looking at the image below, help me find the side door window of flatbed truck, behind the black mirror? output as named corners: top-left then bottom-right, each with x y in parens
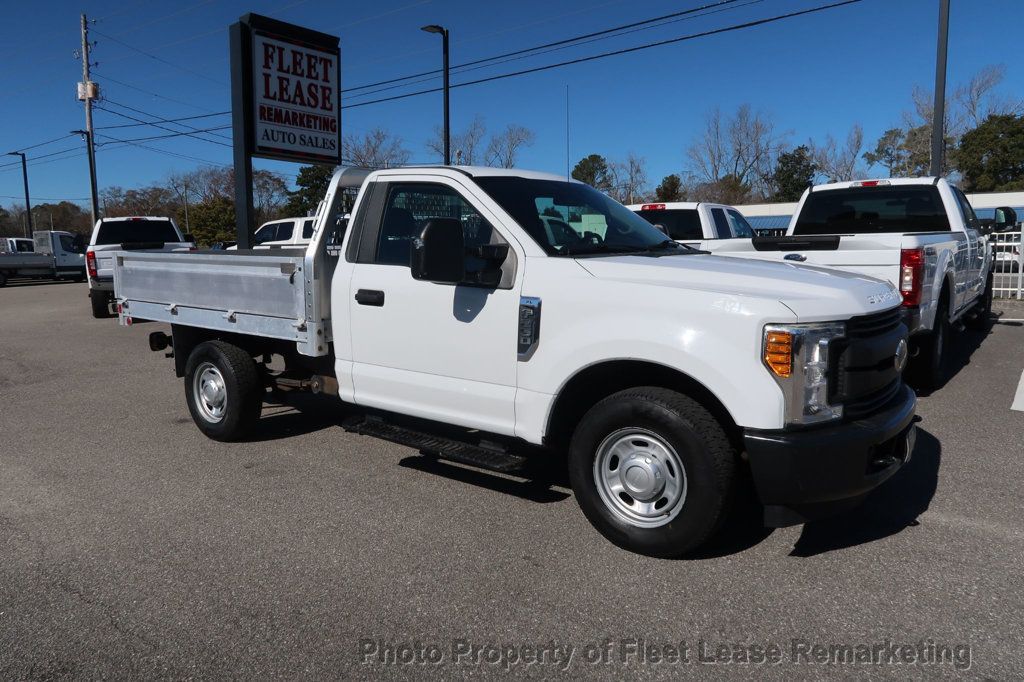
top-left (374, 183), bottom-right (504, 272)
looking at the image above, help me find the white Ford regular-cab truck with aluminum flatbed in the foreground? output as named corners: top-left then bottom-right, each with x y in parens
top-left (114, 167), bottom-right (915, 556)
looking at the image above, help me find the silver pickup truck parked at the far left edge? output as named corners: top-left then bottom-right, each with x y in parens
top-left (0, 229), bottom-right (85, 287)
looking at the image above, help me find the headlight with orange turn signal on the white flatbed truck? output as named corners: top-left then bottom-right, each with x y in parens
top-left (761, 323), bottom-right (846, 426)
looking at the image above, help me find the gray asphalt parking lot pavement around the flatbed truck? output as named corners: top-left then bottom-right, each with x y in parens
top-left (0, 284), bottom-right (1024, 679)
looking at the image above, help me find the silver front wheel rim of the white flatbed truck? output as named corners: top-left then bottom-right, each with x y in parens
top-left (594, 428), bottom-right (686, 528)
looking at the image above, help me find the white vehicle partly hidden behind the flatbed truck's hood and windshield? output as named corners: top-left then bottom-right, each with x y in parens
top-left (627, 202), bottom-right (754, 246)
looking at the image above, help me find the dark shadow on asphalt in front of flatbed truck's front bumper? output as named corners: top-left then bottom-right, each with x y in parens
top-left (790, 428), bottom-right (942, 557)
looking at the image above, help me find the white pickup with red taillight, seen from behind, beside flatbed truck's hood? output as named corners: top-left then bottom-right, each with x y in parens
top-left (716, 177), bottom-right (992, 389)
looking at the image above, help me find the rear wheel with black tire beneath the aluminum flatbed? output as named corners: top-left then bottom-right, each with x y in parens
top-left (184, 341), bottom-right (264, 441)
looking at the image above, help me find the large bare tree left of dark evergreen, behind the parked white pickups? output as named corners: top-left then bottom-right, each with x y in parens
top-left (686, 104), bottom-right (784, 194)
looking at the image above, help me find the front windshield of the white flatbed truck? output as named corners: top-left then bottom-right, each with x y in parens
top-left (474, 176), bottom-right (696, 256)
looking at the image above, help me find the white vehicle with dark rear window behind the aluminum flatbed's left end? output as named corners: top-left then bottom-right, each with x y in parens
top-left (85, 216), bottom-right (196, 317)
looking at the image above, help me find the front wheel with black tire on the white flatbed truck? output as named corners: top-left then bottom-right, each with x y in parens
top-left (568, 386), bottom-right (736, 557)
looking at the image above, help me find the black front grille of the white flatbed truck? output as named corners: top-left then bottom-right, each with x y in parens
top-left (828, 307), bottom-right (906, 420)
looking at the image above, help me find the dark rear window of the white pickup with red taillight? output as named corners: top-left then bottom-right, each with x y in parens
top-left (793, 185), bottom-right (949, 235)
